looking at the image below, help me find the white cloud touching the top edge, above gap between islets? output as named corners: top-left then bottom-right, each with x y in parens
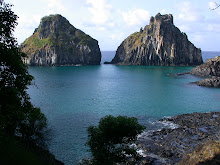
top-left (86, 0), bottom-right (112, 25)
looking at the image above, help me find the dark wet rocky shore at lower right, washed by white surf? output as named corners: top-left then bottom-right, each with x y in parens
top-left (137, 112), bottom-right (220, 165)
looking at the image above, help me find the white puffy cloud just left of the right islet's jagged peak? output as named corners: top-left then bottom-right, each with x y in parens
top-left (122, 9), bottom-right (150, 26)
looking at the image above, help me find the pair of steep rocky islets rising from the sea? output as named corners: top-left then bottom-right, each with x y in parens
top-left (21, 14), bottom-right (202, 66)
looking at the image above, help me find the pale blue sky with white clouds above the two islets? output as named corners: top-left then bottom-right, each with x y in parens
top-left (5, 0), bottom-right (220, 51)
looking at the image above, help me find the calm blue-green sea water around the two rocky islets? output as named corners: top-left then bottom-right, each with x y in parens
top-left (28, 51), bottom-right (220, 165)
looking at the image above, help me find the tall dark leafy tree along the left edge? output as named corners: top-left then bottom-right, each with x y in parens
top-left (0, 0), bottom-right (47, 142)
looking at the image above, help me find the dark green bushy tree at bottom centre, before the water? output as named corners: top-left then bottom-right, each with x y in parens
top-left (87, 115), bottom-right (145, 164)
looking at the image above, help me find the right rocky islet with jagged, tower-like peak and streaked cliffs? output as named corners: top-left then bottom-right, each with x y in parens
top-left (111, 14), bottom-right (203, 66)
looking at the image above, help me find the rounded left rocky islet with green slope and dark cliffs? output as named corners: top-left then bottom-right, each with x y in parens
top-left (21, 14), bottom-right (101, 66)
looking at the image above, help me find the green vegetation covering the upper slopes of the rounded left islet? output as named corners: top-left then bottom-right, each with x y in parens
top-left (22, 15), bottom-right (96, 49)
